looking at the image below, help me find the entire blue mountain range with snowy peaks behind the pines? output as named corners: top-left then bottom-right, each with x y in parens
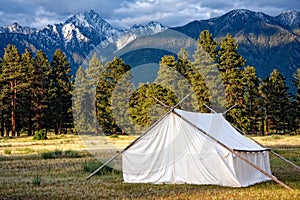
top-left (0, 9), bottom-right (300, 91)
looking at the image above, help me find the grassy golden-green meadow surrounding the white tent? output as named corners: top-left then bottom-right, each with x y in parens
top-left (0, 135), bottom-right (300, 200)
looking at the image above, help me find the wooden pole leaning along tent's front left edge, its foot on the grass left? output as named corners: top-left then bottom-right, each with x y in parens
top-left (86, 94), bottom-right (189, 180)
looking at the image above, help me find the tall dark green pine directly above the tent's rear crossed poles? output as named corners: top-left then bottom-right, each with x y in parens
top-left (219, 34), bottom-right (245, 128)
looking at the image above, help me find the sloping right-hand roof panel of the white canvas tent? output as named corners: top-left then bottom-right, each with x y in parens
top-left (174, 109), bottom-right (269, 151)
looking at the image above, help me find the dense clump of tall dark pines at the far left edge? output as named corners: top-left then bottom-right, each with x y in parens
top-left (0, 45), bottom-right (73, 137)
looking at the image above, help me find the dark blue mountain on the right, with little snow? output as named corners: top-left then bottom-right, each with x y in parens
top-left (173, 10), bottom-right (300, 91)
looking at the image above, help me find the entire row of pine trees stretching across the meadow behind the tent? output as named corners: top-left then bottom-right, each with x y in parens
top-left (0, 31), bottom-right (300, 136)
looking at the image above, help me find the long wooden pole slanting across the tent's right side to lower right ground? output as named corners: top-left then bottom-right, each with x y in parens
top-left (173, 110), bottom-right (293, 190)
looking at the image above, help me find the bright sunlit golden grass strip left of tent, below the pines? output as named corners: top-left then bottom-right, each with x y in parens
top-left (0, 135), bottom-right (137, 156)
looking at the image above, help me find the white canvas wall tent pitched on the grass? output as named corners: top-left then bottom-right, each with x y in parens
top-left (122, 109), bottom-right (272, 187)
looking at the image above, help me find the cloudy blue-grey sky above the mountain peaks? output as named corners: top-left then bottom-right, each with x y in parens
top-left (0, 0), bottom-right (300, 28)
